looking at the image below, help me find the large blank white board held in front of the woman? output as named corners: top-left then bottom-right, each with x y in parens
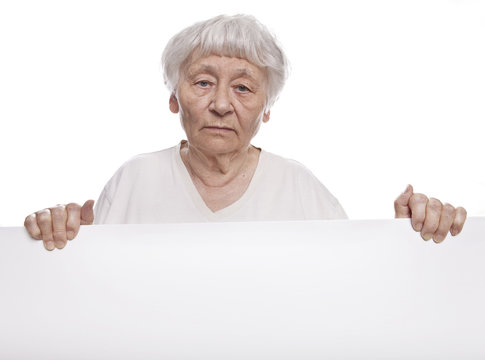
top-left (0, 218), bottom-right (485, 360)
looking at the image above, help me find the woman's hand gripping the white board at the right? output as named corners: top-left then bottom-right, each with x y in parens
top-left (394, 185), bottom-right (466, 243)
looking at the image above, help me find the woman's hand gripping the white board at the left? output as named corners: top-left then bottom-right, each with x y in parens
top-left (24, 200), bottom-right (94, 251)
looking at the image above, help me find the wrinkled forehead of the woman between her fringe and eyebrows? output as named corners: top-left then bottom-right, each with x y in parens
top-left (186, 55), bottom-right (266, 81)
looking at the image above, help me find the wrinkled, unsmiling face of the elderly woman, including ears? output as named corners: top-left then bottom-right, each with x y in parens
top-left (170, 55), bottom-right (269, 155)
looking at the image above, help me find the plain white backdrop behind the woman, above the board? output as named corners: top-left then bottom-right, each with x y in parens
top-left (0, 0), bottom-right (485, 226)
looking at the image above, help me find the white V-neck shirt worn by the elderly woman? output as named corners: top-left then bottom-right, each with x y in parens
top-left (95, 144), bottom-right (347, 224)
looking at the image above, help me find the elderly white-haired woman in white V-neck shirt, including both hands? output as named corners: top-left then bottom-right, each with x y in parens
top-left (25, 15), bottom-right (466, 250)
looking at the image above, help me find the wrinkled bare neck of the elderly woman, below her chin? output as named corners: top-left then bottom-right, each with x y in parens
top-left (180, 142), bottom-right (259, 188)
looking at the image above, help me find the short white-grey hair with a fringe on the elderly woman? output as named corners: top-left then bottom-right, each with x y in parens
top-left (162, 15), bottom-right (288, 109)
